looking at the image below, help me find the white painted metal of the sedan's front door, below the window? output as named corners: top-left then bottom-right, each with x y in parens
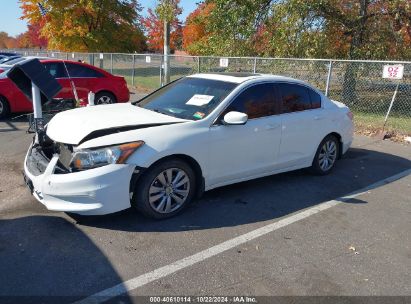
top-left (207, 115), bottom-right (281, 186)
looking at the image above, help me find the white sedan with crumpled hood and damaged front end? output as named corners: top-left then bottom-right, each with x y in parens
top-left (24, 74), bottom-right (353, 218)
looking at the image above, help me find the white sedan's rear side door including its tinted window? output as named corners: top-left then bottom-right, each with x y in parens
top-left (277, 83), bottom-right (326, 169)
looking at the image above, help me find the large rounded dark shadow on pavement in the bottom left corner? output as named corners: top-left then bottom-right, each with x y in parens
top-left (0, 216), bottom-right (132, 303)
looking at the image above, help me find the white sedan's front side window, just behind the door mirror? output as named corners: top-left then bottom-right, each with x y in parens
top-left (222, 83), bottom-right (278, 119)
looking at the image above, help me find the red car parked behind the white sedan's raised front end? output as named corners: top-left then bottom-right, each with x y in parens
top-left (0, 59), bottom-right (130, 118)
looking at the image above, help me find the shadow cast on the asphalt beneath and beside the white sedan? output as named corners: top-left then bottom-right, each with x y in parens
top-left (75, 148), bottom-right (411, 232)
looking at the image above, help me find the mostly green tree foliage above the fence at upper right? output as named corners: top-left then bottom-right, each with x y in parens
top-left (185, 0), bottom-right (411, 59)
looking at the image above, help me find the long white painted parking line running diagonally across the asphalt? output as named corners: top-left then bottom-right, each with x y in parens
top-left (75, 169), bottom-right (411, 304)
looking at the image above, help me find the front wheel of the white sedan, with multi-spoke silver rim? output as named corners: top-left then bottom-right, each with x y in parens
top-left (131, 159), bottom-right (196, 219)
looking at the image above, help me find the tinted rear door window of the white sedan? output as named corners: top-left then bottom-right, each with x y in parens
top-left (278, 83), bottom-right (311, 113)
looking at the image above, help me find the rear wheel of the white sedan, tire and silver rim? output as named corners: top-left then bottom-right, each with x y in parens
top-left (311, 135), bottom-right (340, 175)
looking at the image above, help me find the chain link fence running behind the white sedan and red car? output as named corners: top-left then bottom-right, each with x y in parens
top-left (5, 50), bottom-right (411, 135)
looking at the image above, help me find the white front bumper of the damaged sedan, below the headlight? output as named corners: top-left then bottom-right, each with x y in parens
top-left (24, 145), bottom-right (134, 215)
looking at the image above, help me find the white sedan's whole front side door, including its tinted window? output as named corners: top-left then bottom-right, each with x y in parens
top-left (210, 83), bottom-right (281, 185)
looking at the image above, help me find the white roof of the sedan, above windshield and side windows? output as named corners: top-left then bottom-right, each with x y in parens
top-left (187, 72), bottom-right (303, 83)
